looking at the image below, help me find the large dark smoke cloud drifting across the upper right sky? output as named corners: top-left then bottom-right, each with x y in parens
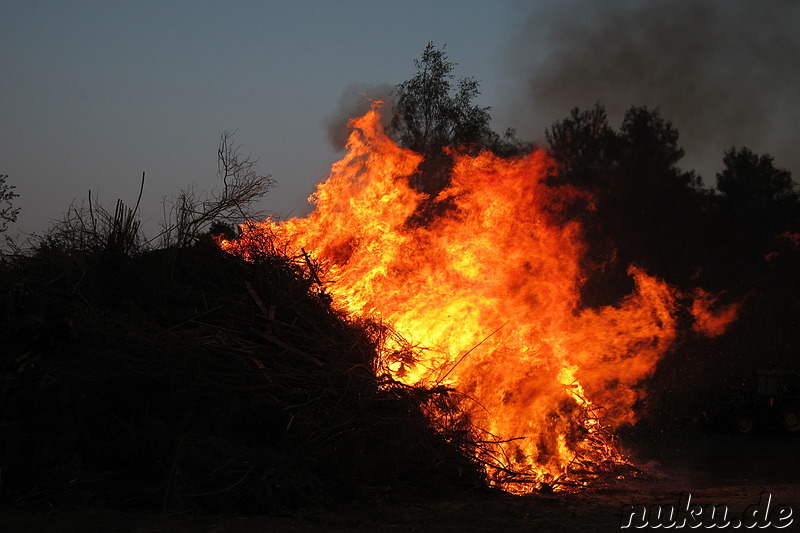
top-left (504, 0), bottom-right (800, 186)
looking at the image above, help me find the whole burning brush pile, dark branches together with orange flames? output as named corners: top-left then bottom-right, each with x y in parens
top-left (0, 105), bottom-right (735, 510)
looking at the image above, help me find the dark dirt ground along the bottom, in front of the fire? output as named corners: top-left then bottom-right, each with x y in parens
top-left (0, 429), bottom-right (800, 533)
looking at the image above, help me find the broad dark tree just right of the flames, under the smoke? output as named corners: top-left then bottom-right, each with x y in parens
top-left (545, 103), bottom-right (702, 306)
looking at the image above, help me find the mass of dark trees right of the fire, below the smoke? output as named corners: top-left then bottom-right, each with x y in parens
top-left (546, 103), bottom-right (800, 434)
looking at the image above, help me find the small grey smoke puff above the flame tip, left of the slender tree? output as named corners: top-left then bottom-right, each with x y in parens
top-left (325, 83), bottom-right (394, 151)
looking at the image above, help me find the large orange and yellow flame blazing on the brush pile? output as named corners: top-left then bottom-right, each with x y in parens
top-left (222, 108), bottom-right (736, 492)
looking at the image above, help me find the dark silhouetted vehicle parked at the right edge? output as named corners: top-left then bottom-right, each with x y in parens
top-left (717, 370), bottom-right (800, 435)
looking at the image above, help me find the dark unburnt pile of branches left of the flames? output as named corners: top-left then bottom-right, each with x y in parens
top-left (0, 229), bottom-right (483, 512)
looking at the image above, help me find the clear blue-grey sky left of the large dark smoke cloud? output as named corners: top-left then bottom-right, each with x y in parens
top-left (0, 0), bottom-right (511, 236)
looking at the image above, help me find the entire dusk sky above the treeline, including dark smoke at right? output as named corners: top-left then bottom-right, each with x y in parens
top-left (0, 0), bottom-right (800, 237)
